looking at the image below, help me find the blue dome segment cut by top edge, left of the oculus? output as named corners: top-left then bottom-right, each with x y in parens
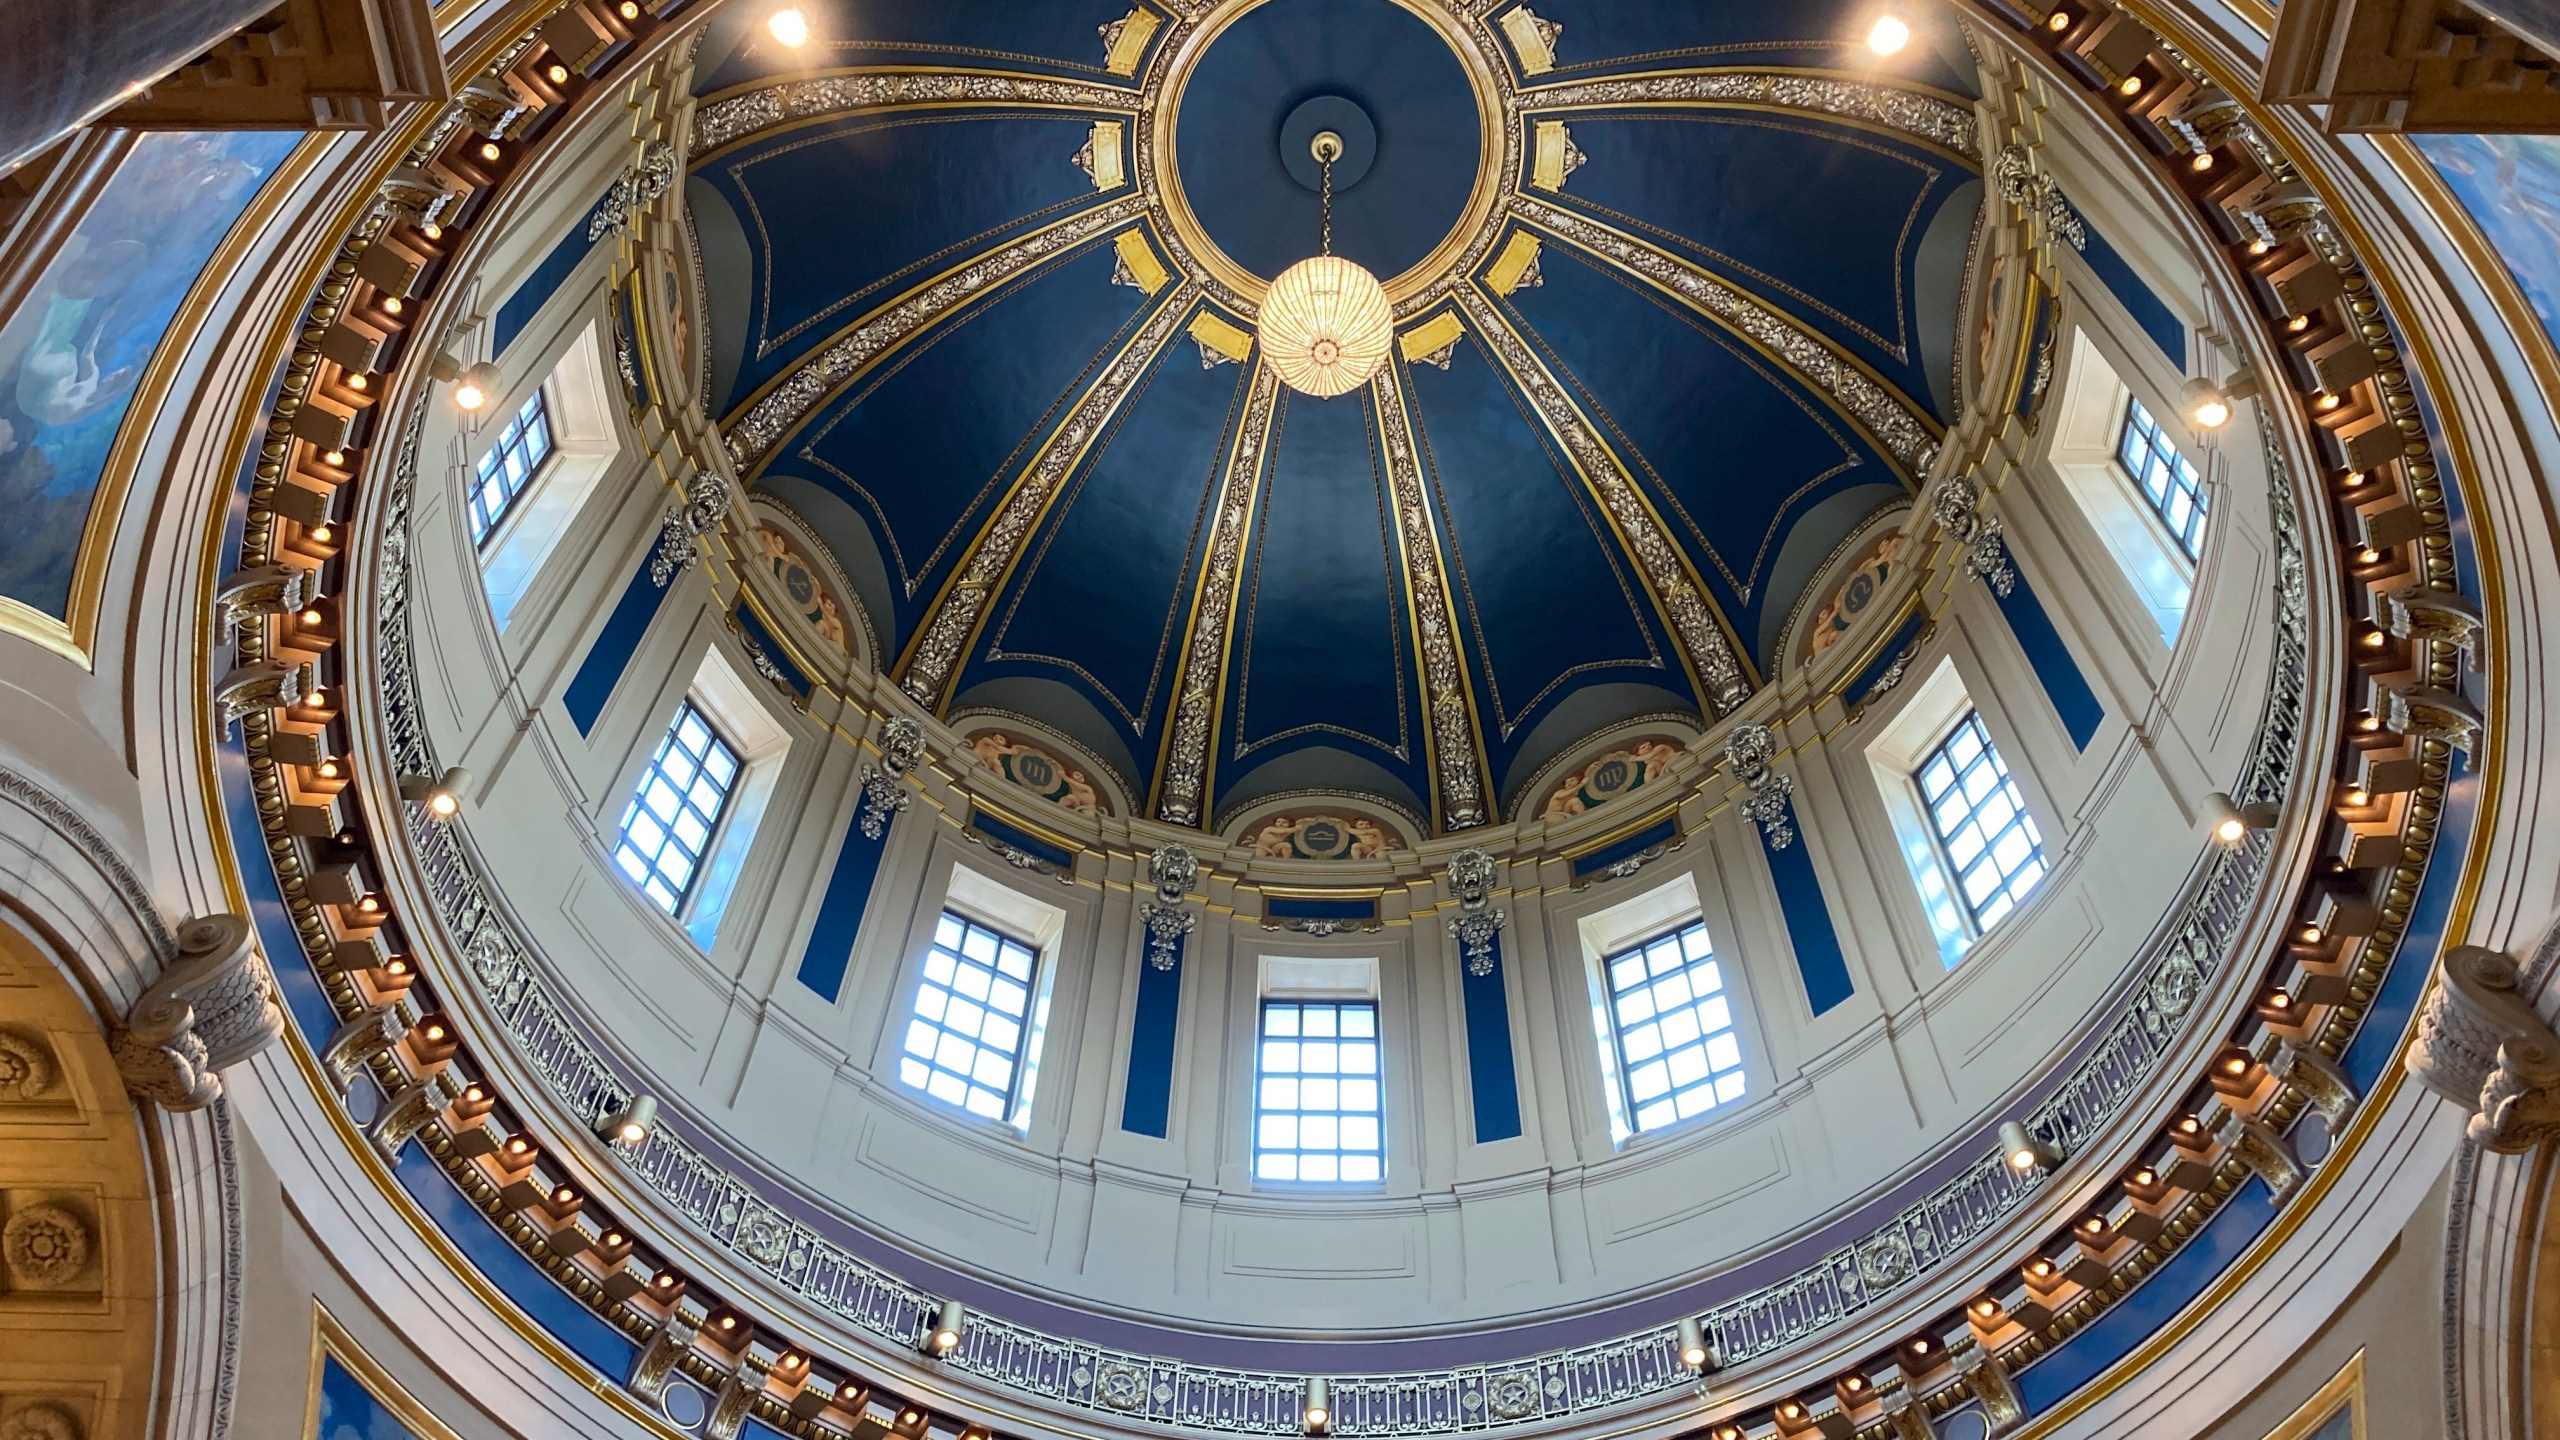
top-left (694, 0), bottom-right (1129, 95)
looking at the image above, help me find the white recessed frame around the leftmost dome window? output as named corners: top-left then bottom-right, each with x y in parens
top-left (478, 318), bottom-right (622, 633)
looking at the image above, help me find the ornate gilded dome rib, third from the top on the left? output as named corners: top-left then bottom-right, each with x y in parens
top-left (899, 284), bottom-right (1201, 715)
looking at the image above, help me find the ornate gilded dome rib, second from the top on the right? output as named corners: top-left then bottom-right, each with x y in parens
top-left (1513, 195), bottom-right (1946, 471)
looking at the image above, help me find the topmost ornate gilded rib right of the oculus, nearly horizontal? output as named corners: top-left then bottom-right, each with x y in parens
top-left (1518, 69), bottom-right (1981, 164)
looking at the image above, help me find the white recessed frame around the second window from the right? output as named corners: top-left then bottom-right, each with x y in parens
top-left (1866, 656), bottom-right (2061, 969)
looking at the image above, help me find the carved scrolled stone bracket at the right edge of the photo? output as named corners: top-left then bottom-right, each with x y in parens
top-left (2406, 945), bottom-right (2560, 1156)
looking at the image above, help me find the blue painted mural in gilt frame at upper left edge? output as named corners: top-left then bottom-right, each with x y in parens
top-left (0, 131), bottom-right (300, 620)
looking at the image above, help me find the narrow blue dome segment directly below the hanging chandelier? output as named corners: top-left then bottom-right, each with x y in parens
top-left (1216, 381), bottom-right (1431, 814)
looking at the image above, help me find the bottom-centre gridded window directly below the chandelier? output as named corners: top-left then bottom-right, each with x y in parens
top-left (1254, 999), bottom-right (1388, 1184)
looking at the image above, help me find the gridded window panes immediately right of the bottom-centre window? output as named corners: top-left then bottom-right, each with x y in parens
top-left (1600, 920), bottom-right (1743, 1133)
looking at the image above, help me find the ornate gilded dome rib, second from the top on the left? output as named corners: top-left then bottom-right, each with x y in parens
top-left (722, 195), bottom-right (1147, 458)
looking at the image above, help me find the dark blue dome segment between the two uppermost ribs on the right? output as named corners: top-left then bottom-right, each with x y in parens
top-left (1559, 110), bottom-right (1971, 404)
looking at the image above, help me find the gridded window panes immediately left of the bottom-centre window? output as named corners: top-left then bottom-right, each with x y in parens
top-left (899, 910), bottom-right (1039, 1120)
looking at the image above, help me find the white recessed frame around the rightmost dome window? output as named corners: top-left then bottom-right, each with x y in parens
top-left (2045, 328), bottom-right (2222, 646)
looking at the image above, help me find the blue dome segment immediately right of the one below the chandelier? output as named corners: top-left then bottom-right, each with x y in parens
top-left (1408, 336), bottom-right (1687, 774)
